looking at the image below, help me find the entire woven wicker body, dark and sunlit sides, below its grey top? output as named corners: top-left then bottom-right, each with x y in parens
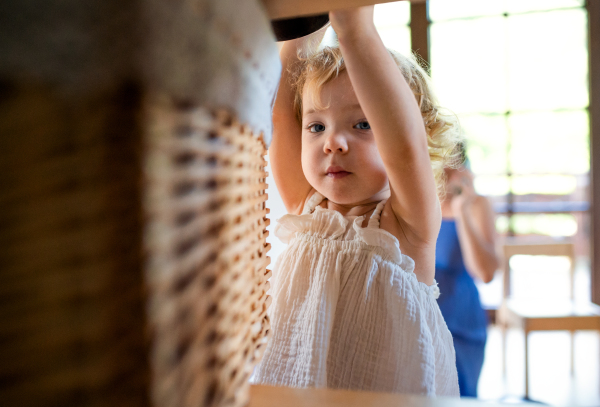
top-left (0, 85), bottom-right (270, 407)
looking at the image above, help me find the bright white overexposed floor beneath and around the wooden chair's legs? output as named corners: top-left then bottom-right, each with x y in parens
top-left (478, 327), bottom-right (600, 407)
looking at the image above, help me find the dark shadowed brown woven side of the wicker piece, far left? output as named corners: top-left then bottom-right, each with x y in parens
top-left (0, 82), bottom-right (150, 406)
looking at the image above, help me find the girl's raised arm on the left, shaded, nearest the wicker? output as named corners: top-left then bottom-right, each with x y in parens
top-left (269, 29), bottom-right (325, 213)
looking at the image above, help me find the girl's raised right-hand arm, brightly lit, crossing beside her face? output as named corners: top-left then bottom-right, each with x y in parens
top-left (330, 7), bottom-right (441, 246)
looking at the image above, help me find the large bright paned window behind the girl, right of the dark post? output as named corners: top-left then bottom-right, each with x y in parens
top-left (429, 0), bottom-right (589, 242)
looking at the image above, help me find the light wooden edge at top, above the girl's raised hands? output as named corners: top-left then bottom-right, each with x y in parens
top-left (262, 0), bottom-right (425, 20)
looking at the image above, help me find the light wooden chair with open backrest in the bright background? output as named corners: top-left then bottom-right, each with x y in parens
top-left (497, 243), bottom-right (600, 399)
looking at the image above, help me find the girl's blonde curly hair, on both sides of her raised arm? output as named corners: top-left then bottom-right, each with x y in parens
top-left (291, 47), bottom-right (463, 197)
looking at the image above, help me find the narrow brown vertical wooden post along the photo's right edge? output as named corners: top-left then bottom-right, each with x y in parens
top-left (587, 0), bottom-right (600, 304)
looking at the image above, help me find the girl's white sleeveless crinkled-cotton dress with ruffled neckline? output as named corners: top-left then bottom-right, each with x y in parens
top-left (251, 193), bottom-right (459, 396)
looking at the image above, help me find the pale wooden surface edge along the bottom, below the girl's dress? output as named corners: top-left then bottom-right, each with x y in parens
top-left (247, 386), bottom-right (538, 407)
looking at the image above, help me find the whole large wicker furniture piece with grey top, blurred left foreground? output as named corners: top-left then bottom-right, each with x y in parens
top-left (0, 0), bottom-right (281, 407)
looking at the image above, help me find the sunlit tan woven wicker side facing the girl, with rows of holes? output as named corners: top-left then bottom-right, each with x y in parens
top-left (144, 100), bottom-right (270, 407)
